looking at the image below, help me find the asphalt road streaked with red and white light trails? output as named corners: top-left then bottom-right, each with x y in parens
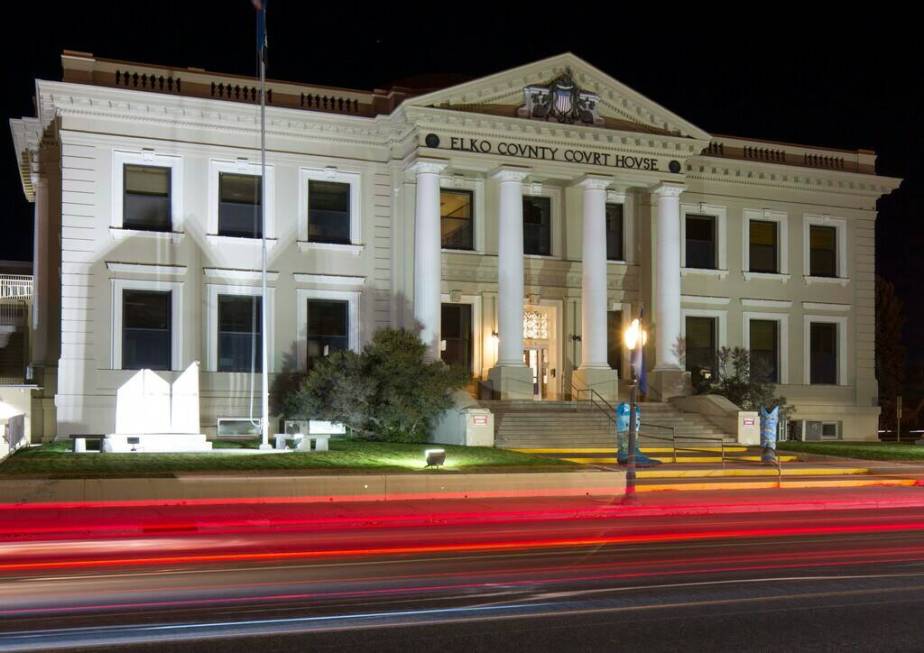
top-left (0, 496), bottom-right (924, 653)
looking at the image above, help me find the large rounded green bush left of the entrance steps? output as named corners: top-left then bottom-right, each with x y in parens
top-left (281, 329), bottom-right (468, 442)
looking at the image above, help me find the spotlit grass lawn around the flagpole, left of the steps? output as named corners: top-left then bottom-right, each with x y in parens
top-left (0, 439), bottom-right (580, 478)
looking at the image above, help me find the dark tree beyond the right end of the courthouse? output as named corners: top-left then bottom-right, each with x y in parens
top-left (876, 276), bottom-right (905, 429)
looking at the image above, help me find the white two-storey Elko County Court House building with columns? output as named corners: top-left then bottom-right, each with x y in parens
top-left (10, 52), bottom-right (899, 440)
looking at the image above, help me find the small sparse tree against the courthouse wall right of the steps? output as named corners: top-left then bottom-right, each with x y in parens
top-left (694, 347), bottom-right (792, 414)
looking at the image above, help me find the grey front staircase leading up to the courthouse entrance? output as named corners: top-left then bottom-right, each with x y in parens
top-left (488, 400), bottom-right (735, 449)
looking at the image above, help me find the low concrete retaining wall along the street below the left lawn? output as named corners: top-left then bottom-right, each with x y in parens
top-left (0, 471), bottom-right (626, 504)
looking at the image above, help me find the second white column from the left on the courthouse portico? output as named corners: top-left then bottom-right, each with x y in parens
top-left (494, 169), bottom-right (527, 367)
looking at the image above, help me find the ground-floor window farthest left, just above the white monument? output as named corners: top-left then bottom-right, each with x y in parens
top-left (122, 290), bottom-right (173, 370)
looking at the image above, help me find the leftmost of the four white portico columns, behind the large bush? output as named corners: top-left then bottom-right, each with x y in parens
top-left (412, 160), bottom-right (446, 360)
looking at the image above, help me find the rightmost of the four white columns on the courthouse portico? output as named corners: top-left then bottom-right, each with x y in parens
top-left (652, 183), bottom-right (684, 370)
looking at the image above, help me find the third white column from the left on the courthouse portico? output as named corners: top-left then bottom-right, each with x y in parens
top-left (580, 177), bottom-right (610, 370)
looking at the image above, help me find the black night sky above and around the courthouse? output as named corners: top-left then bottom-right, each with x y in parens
top-left (0, 5), bottom-right (924, 362)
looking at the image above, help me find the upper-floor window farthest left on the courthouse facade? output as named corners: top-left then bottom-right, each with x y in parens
top-left (122, 164), bottom-right (172, 231)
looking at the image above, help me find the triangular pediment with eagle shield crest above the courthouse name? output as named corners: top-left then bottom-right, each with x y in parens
top-left (404, 53), bottom-right (710, 140)
